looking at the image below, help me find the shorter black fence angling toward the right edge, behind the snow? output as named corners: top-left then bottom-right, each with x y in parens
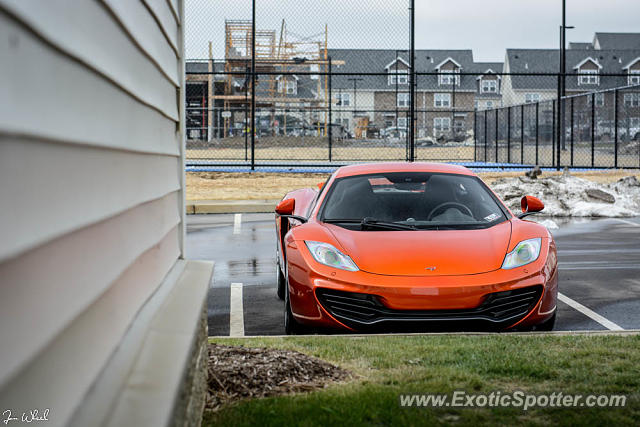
top-left (475, 80), bottom-right (640, 168)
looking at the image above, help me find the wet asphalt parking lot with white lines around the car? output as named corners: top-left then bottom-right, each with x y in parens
top-left (187, 214), bottom-right (640, 336)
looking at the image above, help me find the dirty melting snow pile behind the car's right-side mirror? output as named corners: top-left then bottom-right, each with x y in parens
top-left (491, 175), bottom-right (640, 217)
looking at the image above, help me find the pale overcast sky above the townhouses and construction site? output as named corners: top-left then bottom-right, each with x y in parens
top-left (185, 0), bottom-right (640, 62)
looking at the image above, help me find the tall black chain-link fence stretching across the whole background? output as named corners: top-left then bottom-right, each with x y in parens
top-left (186, 0), bottom-right (640, 171)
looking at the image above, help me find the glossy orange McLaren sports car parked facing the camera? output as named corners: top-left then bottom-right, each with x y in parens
top-left (276, 163), bottom-right (558, 334)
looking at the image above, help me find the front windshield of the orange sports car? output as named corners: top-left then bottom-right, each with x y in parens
top-left (320, 172), bottom-right (506, 230)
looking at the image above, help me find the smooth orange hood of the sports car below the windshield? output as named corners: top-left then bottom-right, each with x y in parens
top-left (326, 221), bottom-right (511, 276)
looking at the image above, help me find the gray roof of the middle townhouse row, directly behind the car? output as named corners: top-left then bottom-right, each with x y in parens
top-left (328, 49), bottom-right (492, 91)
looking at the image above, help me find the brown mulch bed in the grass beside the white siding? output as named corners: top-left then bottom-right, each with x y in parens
top-left (206, 344), bottom-right (352, 411)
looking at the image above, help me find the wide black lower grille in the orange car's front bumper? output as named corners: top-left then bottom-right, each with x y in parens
top-left (316, 285), bottom-right (542, 329)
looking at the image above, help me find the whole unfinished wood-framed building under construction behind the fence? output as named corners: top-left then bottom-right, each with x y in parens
top-left (187, 20), bottom-right (338, 139)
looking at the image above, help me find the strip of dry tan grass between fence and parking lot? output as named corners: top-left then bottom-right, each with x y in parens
top-left (187, 170), bottom-right (640, 200)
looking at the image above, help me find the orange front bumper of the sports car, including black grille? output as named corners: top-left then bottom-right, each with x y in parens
top-left (287, 239), bottom-right (558, 331)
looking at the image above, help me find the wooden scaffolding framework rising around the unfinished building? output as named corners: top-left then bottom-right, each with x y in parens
top-left (213, 19), bottom-right (339, 136)
